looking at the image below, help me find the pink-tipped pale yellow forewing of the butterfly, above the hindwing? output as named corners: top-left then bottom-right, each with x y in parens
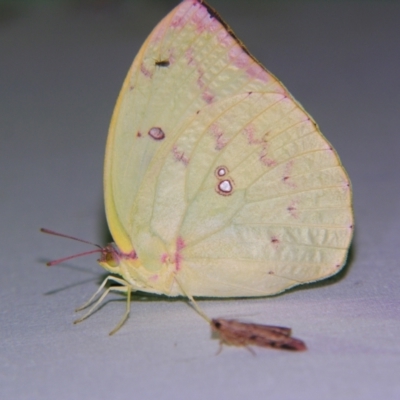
top-left (105, 1), bottom-right (283, 250)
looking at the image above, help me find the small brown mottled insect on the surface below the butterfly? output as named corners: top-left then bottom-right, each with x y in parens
top-left (210, 318), bottom-right (307, 351)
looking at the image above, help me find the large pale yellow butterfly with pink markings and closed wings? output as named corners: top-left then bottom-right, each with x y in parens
top-left (46, 0), bottom-right (353, 332)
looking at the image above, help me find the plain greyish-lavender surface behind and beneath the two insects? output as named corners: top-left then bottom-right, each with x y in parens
top-left (0, 0), bottom-right (400, 400)
